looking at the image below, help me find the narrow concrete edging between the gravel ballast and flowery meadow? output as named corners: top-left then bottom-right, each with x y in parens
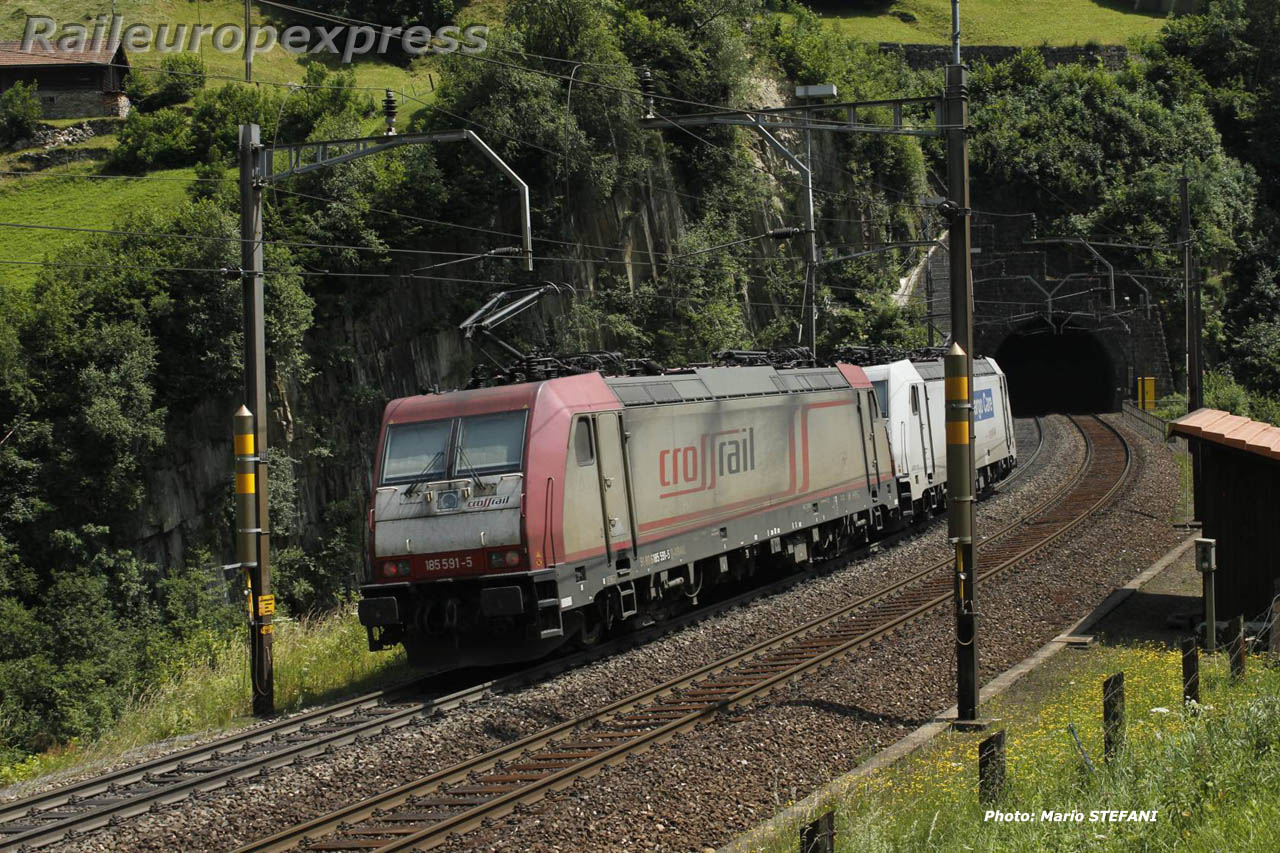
top-left (717, 532), bottom-right (1199, 853)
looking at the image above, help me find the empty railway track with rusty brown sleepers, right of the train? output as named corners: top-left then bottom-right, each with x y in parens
top-left (238, 418), bottom-right (1130, 853)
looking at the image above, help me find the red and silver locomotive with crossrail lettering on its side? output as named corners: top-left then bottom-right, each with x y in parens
top-left (360, 364), bottom-right (897, 666)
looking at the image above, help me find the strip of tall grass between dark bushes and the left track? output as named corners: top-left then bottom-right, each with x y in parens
top-left (0, 608), bottom-right (411, 784)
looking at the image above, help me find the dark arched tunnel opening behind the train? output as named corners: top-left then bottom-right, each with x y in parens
top-left (996, 324), bottom-right (1114, 416)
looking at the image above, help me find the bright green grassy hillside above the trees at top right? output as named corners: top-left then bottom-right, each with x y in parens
top-left (810, 0), bottom-right (1165, 46)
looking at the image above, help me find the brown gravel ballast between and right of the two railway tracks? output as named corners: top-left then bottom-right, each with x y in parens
top-left (40, 418), bottom-right (1176, 850)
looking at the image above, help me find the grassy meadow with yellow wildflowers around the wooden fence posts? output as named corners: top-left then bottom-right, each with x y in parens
top-left (765, 647), bottom-right (1280, 853)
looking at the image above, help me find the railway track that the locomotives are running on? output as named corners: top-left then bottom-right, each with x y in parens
top-left (0, 419), bottom-right (1043, 850)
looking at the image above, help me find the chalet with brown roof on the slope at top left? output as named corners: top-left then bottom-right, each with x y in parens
top-left (0, 41), bottom-right (129, 118)
